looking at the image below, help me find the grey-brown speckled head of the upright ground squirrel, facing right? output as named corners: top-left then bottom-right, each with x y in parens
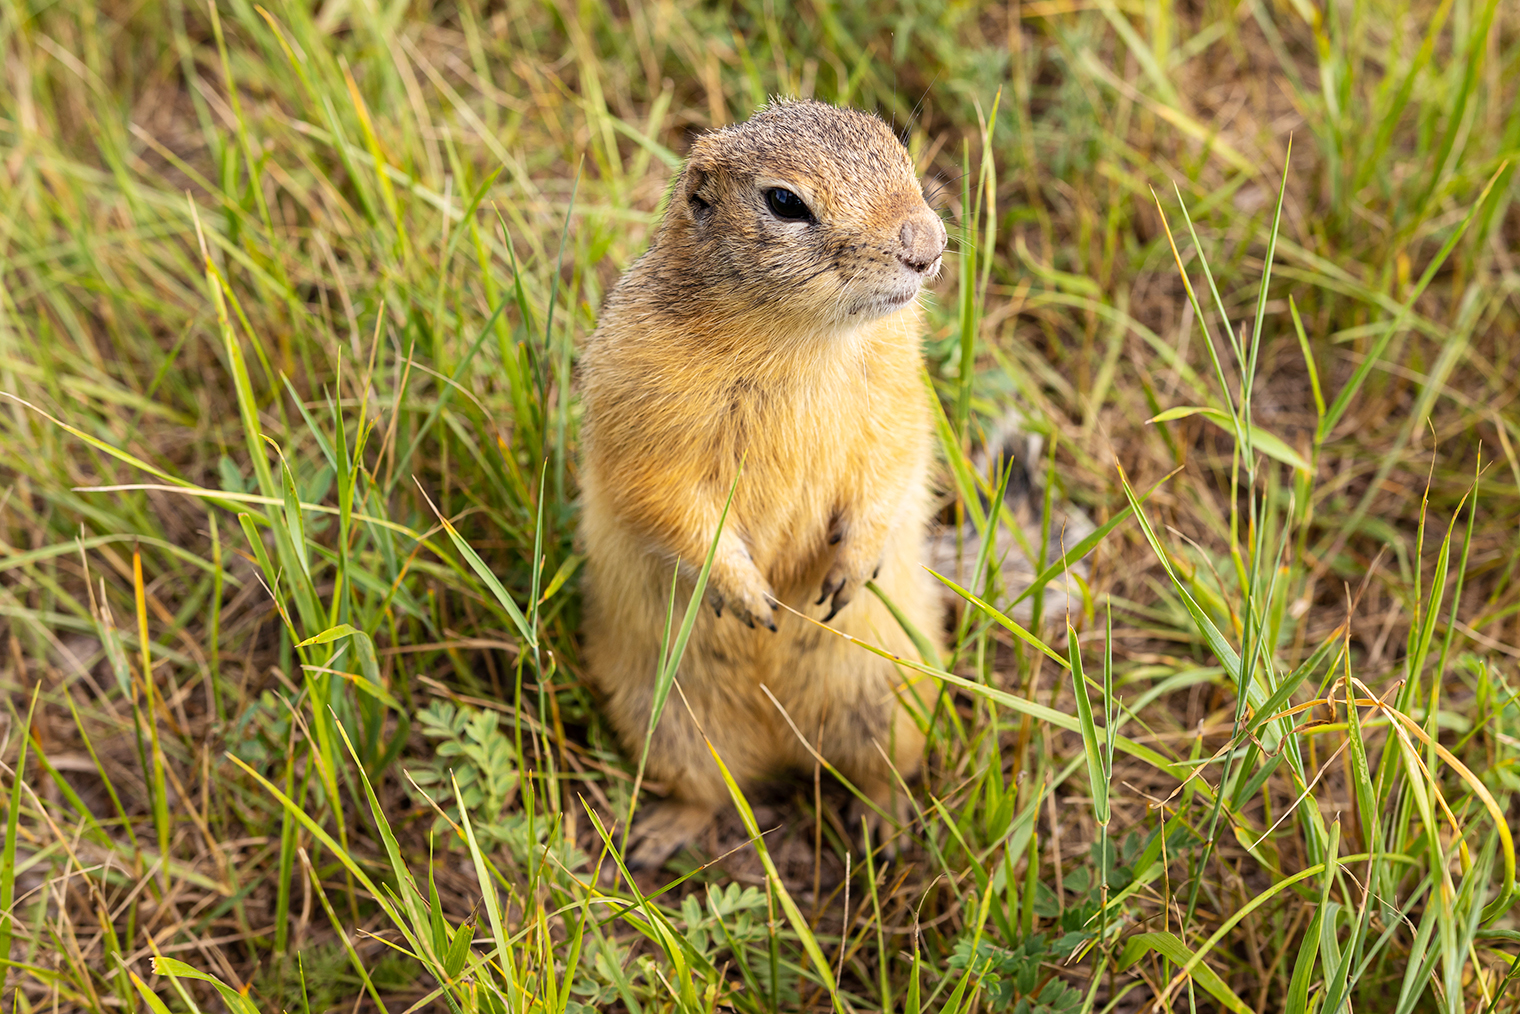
top-left (657, 100), bottom-right (945, 330)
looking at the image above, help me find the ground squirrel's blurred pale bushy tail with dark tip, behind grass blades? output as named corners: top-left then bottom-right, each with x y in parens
top-left (929, 409), bottom-right (1094, 626)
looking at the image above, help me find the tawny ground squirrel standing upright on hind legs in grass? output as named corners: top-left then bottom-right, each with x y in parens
top-left (581, 100), bottom-right (945, 865)
